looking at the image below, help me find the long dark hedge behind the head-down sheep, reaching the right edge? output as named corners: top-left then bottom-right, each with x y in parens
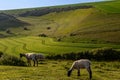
top-left (47, 48), bottom-right (120, 61)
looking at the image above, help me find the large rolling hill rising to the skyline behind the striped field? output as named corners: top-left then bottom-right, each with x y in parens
top-left (0, 0), bottom-right (120, 43)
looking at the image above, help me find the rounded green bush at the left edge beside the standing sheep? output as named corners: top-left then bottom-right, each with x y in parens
top-left (0, 54), bottom-right (26, 66)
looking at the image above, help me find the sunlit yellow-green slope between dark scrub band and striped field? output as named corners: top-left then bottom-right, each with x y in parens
top-left (13, 3), bottom-right (120, 43)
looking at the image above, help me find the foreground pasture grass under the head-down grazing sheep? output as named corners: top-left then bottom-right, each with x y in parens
top-left (0, 60), bottom-right (120, 80)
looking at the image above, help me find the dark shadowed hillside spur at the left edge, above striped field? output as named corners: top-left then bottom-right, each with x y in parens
top-left (0, 13), bottom-right (30, 38)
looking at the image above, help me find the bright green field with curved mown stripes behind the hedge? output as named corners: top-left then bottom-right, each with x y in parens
top-left (0, 36), bottom-right (120, 56)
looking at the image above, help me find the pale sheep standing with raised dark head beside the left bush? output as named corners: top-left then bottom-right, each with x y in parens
top-left (20, 53), bottom-right (45, 66)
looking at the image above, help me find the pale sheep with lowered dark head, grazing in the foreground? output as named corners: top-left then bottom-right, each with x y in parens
top-left (68, 59), bottom-right (92, 80)
